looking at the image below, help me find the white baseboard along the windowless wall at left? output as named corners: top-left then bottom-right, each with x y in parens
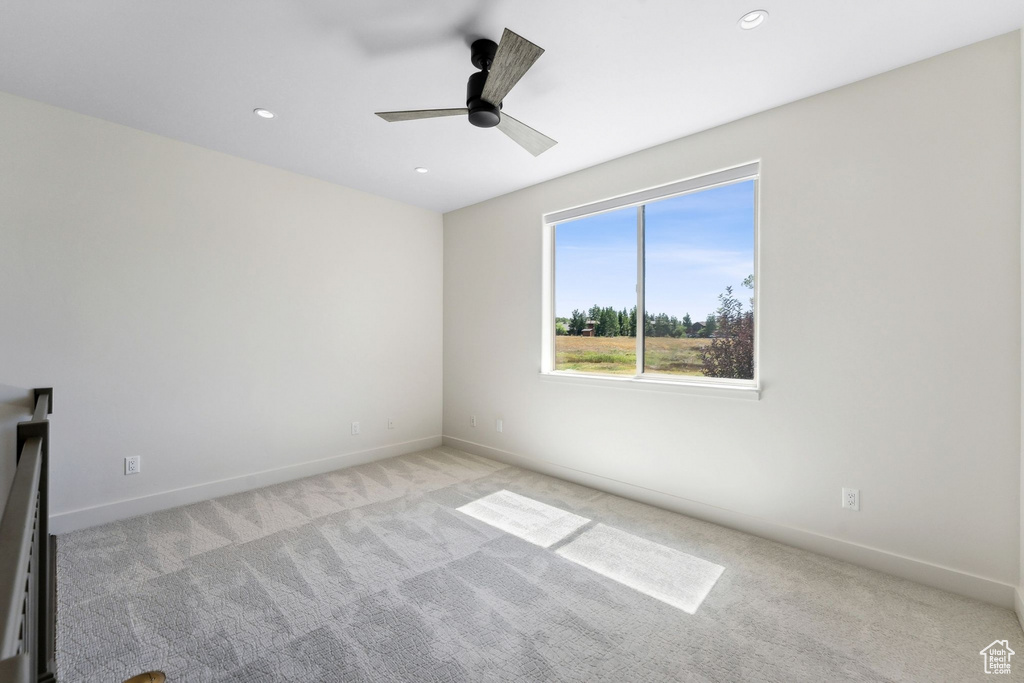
top-left (49, 436), bottom-right (441, 535)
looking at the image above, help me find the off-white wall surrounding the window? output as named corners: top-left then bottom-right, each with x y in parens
top-left (444, 33), bottom-right (1021, 604)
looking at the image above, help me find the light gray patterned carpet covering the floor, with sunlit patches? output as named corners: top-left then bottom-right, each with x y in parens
top-left (57, 449), bottom-right (1024, 683)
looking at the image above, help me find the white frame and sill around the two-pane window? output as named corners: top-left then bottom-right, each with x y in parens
top-left (541, 161), bottom-right (762, 399)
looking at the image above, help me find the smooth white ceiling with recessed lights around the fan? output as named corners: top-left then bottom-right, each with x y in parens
top-left (0, 0), bottom-right (1024, 211)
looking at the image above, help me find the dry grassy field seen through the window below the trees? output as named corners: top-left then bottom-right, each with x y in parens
top-left (555, 337), bottom-right (711, 376)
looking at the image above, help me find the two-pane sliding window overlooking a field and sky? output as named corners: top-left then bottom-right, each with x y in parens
top-left (545, 164), bottom-right (758, 386)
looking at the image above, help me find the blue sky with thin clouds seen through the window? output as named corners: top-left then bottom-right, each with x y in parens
top-left (555, 180), bottom-right (754, 322)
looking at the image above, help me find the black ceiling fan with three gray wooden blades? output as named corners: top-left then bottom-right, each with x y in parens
top-left (377, 29), bottom-right (557, 157)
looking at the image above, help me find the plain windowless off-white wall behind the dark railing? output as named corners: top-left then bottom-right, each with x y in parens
top-left (0, 94), bottom-right (442, 530)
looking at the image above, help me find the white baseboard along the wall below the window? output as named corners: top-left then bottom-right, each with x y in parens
top-left (443, 436), bottom-right (1024, 610)
